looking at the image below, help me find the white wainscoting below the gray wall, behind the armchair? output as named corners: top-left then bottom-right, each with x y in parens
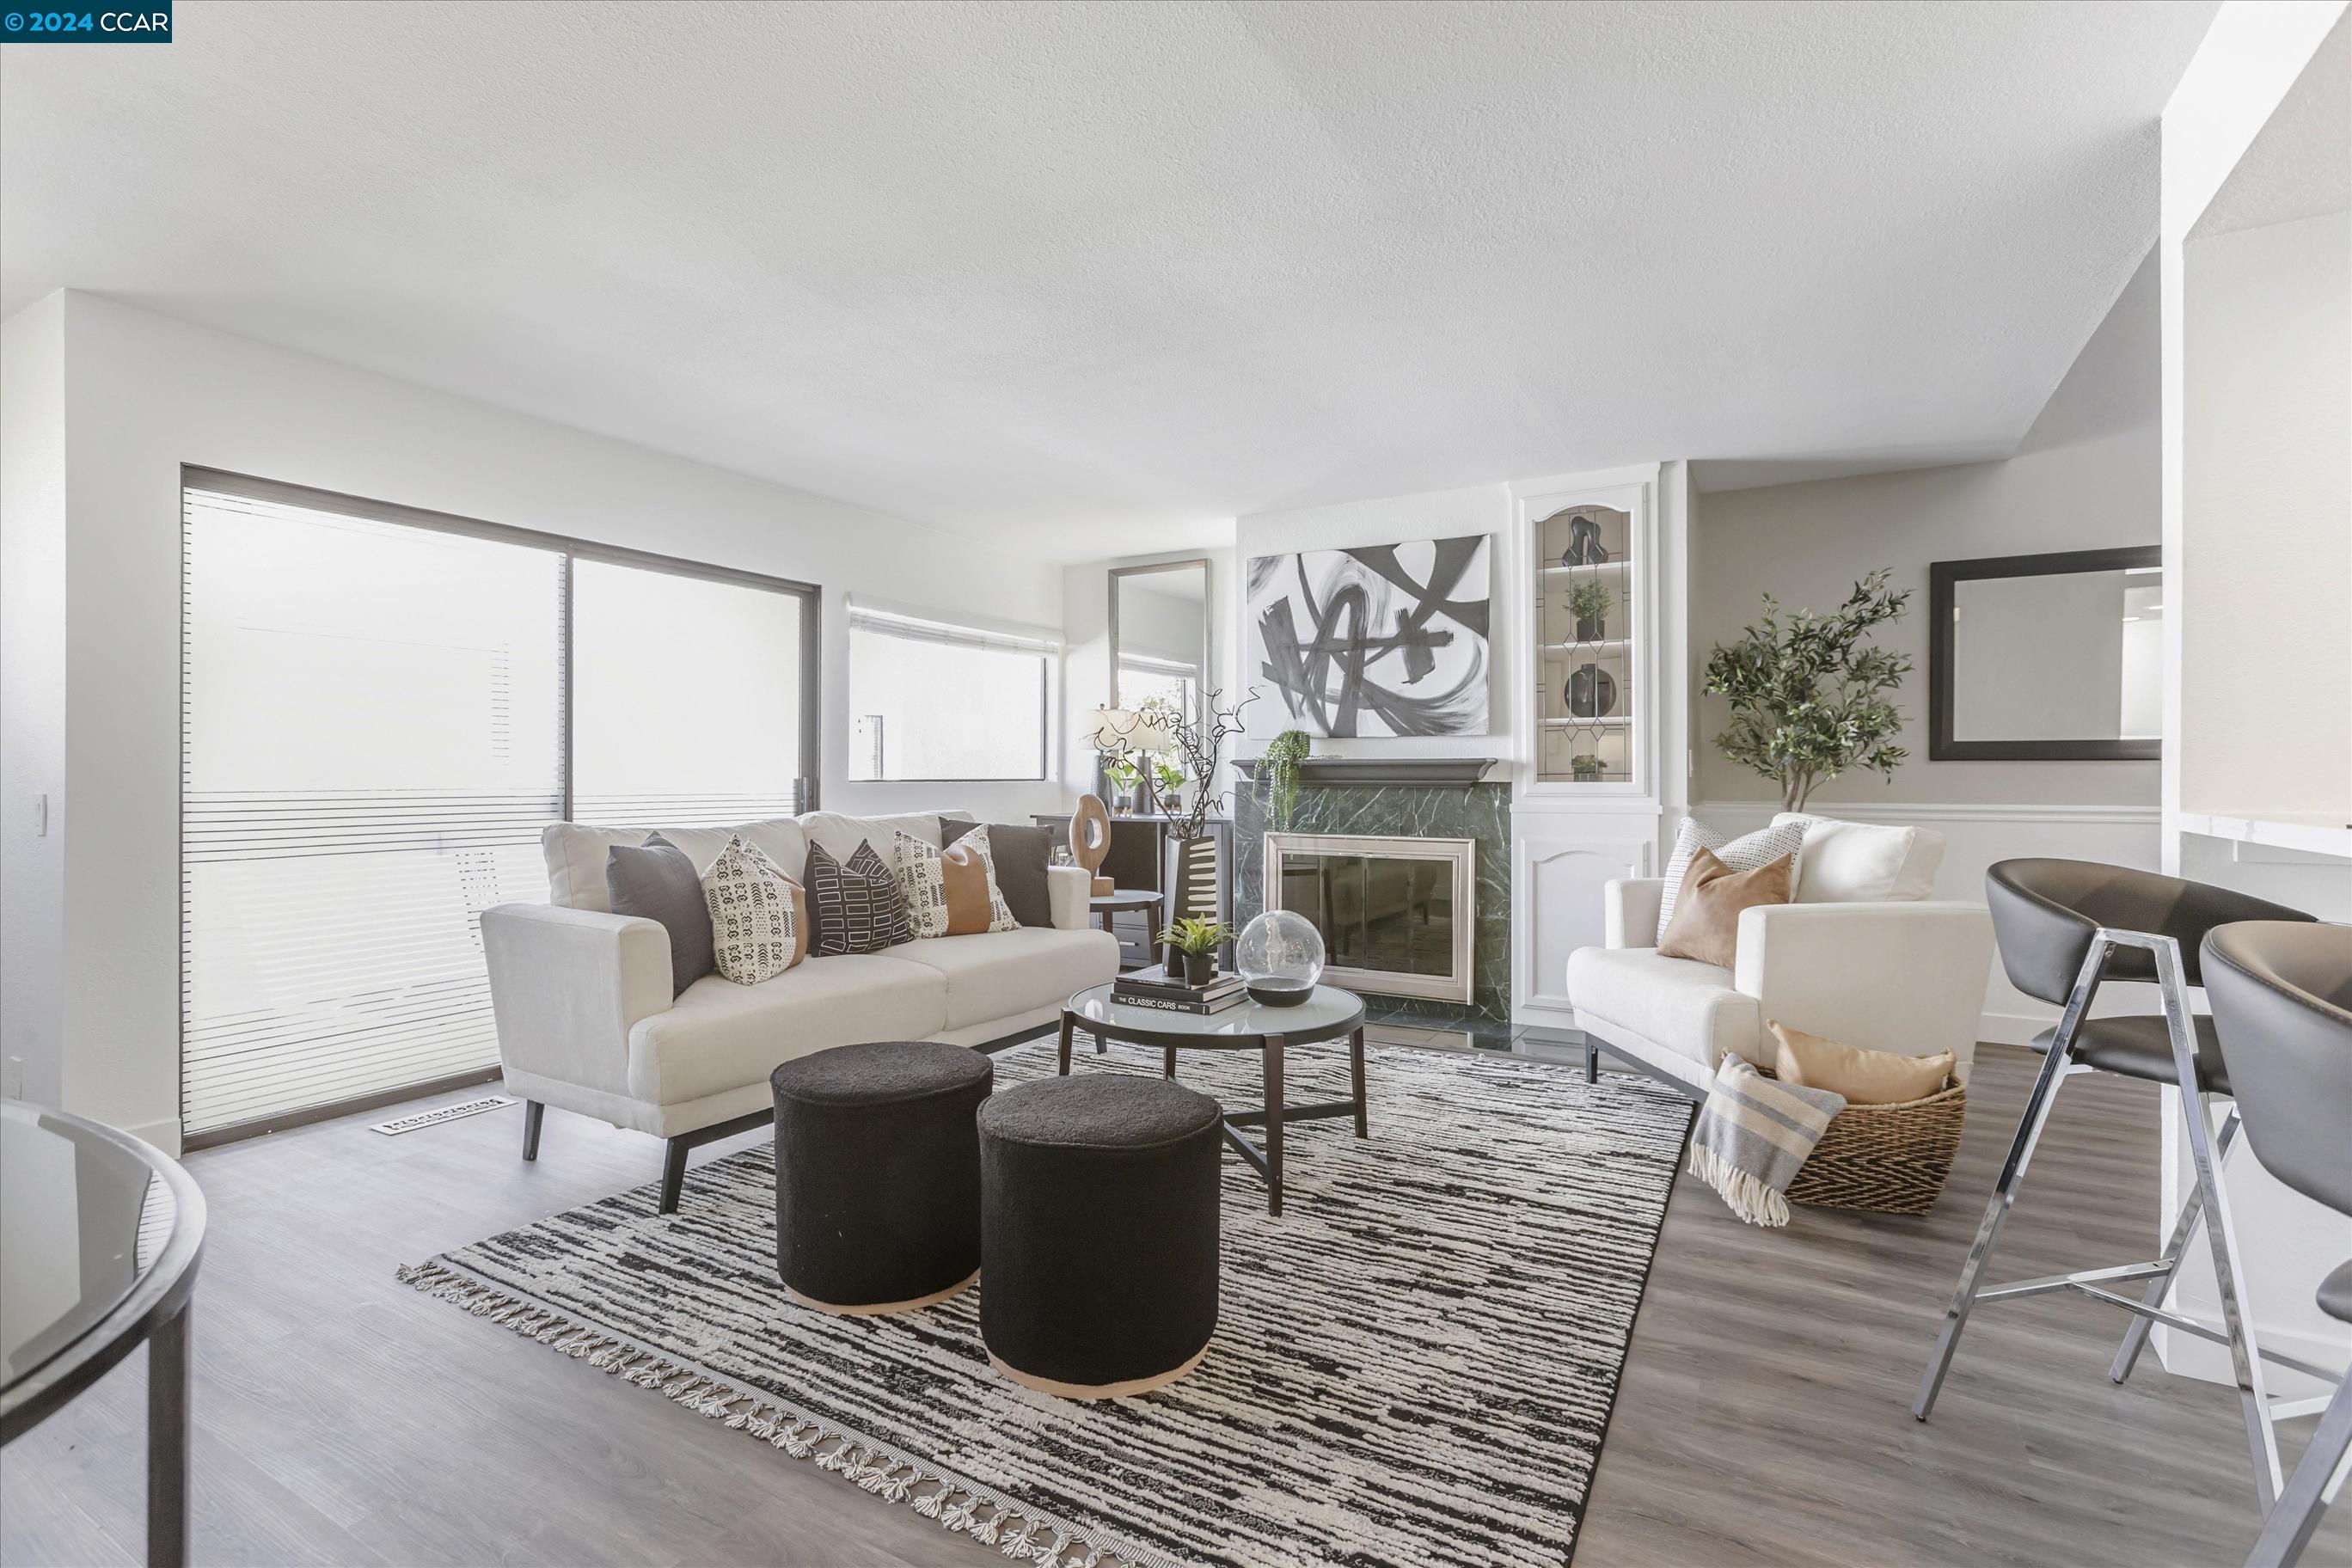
top-left (1691, 799), bottom-right (2161, 1046)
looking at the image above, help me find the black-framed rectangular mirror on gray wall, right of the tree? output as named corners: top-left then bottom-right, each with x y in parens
top-left (1926, 545), bottom-right (2164, 762)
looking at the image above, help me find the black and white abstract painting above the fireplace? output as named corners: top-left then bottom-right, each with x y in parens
top-left (1244, 534), bottom-right (1493, 736)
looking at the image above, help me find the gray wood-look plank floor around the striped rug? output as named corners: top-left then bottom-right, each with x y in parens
top-left (0, 1049), bottom-right (2352, 1568)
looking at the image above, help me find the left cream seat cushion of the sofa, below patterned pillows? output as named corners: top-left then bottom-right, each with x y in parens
top-left (628, 938), bottom-right (952, 1105)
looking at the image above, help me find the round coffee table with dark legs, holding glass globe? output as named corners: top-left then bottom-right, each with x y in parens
top-left (1061, 985), bottom-right (1371, 1216)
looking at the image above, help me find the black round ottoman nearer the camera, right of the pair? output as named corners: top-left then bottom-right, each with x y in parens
top-left (981, 1072), bottom-right (1223, 1399)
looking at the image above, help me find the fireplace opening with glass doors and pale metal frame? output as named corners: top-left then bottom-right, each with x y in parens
top-left (1265, 832), bottom-right (1477, 1004)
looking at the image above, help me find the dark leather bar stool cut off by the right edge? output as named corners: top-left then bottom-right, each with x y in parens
top-left (2204, 919), bottom-right (2352, 1568)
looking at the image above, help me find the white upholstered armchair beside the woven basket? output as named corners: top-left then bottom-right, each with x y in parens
top-left (1569, 877), bottom-right (1992, 1095)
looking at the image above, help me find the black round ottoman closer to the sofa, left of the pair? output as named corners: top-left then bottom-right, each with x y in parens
top-left (769, 1039), bottom-right (995, 1312)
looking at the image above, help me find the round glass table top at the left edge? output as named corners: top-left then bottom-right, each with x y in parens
top-left (0, 1100), bottom-right (202, 1392)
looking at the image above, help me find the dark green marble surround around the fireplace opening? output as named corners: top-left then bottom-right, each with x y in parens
top-left (1233, 757), bottom-right (1510, 1044)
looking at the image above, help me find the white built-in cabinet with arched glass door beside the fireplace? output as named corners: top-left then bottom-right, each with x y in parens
top-left (1496, 465), bottom-right (1688, 1030)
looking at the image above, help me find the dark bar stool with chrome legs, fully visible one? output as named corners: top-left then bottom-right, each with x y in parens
top-left (1912, 861), bottom-right (2329, 1510)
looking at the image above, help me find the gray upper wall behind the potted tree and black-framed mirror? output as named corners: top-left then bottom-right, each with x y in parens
top-left (1691, 256), bottom-right (2161, 806)
